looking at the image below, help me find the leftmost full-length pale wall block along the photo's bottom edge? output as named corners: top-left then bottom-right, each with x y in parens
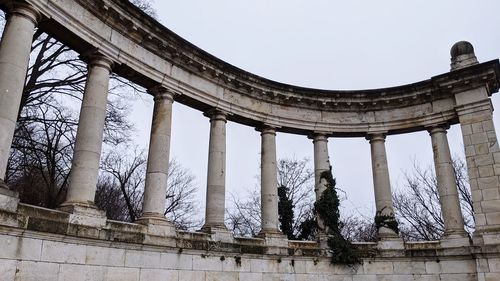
top-left (15, 261), bottom-right (59, 281)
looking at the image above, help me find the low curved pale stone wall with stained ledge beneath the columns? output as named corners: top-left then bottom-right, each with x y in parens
top-left (0, 205), bottom-right (500, 281)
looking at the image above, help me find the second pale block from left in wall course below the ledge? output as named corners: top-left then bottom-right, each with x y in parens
top-left (41, 240), bottom-right (87, 264)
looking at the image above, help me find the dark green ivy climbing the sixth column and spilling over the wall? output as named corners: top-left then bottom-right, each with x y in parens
top-left (314, 168), bottom-right (361, 265)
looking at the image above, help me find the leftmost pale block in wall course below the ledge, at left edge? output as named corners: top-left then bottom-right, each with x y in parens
top-left (0, 235), bottom-right (42, 261)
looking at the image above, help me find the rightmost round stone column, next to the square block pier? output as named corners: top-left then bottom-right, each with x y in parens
top-left (429, 126), bottom-right (467, 238)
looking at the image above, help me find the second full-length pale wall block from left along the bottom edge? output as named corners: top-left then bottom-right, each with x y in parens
top-left (58, 264), bottom-right (106, 281)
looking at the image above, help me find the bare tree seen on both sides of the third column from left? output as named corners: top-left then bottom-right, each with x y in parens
top-left (95, 148), bottom-right (201, 230)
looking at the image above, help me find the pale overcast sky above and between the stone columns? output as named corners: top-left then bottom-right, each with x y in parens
top-left (129, 0), bottom-right (500, 219)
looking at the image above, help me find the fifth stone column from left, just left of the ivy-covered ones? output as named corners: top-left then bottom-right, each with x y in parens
top-left (260, 126), bottom-right (280, 235)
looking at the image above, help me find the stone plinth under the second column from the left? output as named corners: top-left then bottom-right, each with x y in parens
top-left (58, 202), bottom-right (107, 228)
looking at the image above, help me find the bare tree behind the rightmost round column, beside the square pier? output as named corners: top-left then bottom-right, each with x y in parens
top-left (393, 158), bottom-right (474, 240)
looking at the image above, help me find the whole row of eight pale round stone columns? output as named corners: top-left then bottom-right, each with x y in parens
top-left (0, 1), bottom-right (496, 243)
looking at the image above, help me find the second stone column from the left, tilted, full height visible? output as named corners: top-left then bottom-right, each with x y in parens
top-left (61, 55), bottom-right (112, 215)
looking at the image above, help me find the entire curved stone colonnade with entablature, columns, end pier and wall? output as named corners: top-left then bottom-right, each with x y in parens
top-left (0, 0), bottom-right (500, 280)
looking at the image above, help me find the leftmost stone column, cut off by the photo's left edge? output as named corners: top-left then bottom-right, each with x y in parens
top-left (0, 2), bottom-right (40, 212)
